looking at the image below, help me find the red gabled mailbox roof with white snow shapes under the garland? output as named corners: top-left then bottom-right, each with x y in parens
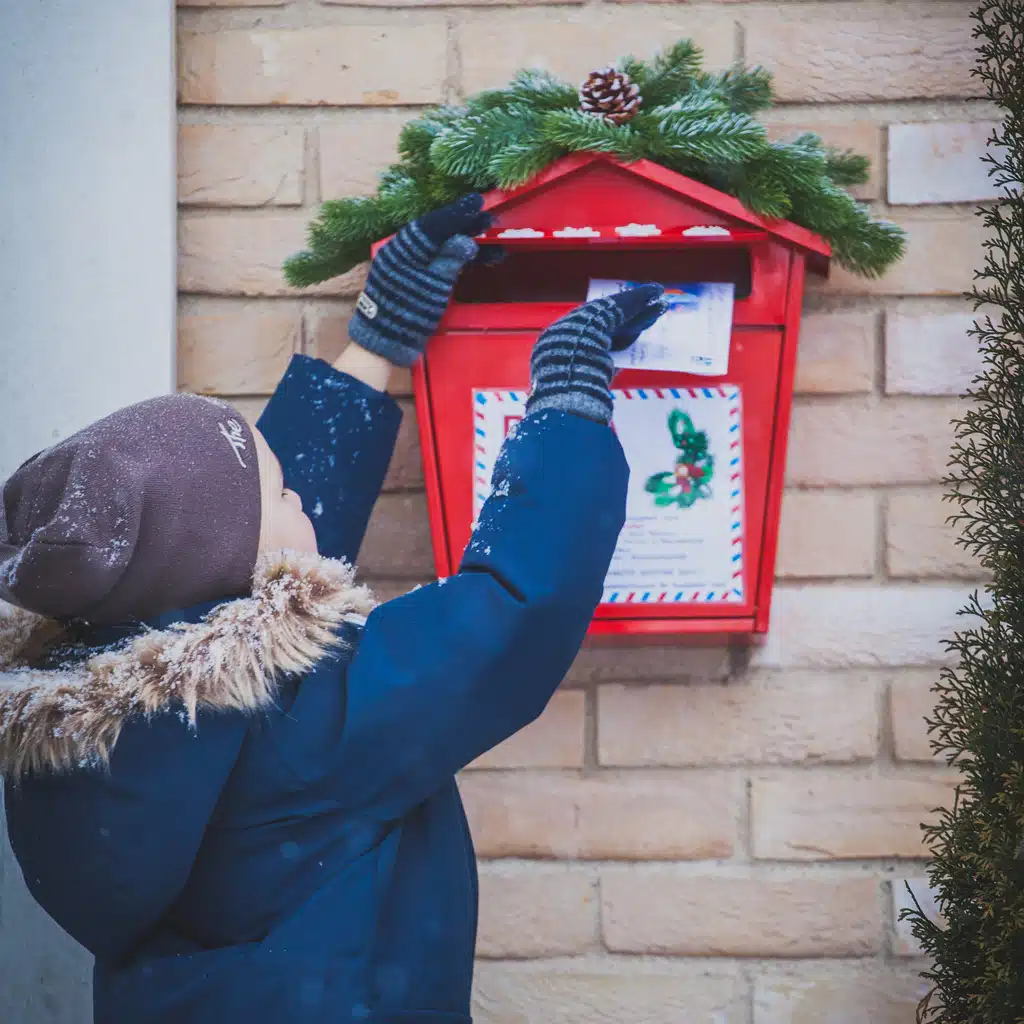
top-left (471, 154), bottom-right (831, 272)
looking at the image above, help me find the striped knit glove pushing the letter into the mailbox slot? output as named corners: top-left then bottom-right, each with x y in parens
top-left (526, 285), bottom-right (666, 424)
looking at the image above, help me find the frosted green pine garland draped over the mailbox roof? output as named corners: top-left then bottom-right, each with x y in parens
top-left (285, 40), bottom-right (904, 288)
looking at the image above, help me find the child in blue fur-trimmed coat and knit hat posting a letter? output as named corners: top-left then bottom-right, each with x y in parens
top-left (0, 197), bottom-right (662, 1024)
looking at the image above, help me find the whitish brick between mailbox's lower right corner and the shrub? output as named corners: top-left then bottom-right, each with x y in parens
top-left (752, 584), bottom-right (969, 669)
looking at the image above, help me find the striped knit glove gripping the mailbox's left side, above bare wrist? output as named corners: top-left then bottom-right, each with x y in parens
top-left (348, 194), bottom-right (493, 367)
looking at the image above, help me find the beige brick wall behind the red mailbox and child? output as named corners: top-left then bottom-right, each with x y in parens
top-left (179, 0), bottom-right (996, 1024)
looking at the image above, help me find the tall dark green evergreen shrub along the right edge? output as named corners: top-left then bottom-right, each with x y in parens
top-left (903, 0), bottom-right (1024, 1024)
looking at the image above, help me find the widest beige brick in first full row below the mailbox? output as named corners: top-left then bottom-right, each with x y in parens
top-left (598, 673), bottom-right (879, 767)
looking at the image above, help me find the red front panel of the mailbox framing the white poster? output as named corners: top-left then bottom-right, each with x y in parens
top-left (416, 327), bottom-right (784, 635)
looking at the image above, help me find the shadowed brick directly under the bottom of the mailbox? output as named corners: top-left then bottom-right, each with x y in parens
top-left (566, 644), bottom-right (729, 684)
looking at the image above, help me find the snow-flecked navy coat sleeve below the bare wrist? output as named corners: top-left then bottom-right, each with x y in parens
top-left (256, 355), bottom-right (401, 562)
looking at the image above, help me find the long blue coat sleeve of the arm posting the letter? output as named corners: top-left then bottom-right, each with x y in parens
top-left (321, 412), bottom-right (629, 820)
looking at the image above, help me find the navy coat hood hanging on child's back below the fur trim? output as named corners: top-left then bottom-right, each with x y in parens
top-left (5, 712), bottom-right (247, 963)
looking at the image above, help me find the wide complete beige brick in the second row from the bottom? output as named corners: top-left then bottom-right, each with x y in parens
top-left (601, 864), bottom-right (882, 956)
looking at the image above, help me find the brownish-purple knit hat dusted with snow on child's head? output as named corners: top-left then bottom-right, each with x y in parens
top-left (0, 394), bottom-right (260, 625)
